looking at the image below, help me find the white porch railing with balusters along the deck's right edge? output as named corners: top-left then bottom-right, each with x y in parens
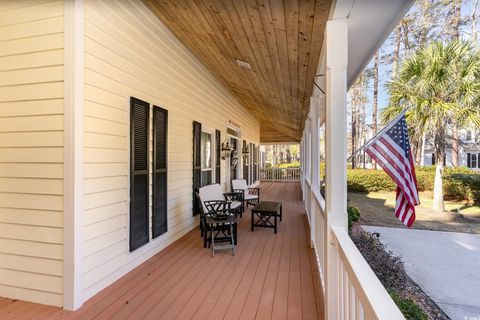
top-left (302, 178), bottom-right (405, 320)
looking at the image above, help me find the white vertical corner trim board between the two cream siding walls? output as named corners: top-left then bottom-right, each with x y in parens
top-left (63, 0), bottom-right (85, 310)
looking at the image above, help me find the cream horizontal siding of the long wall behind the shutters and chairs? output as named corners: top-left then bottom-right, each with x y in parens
top-left (83, 0), bottom-right (260, 298)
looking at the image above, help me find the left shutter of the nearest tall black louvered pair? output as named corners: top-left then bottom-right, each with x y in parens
top-left (130, 97), bottom-right (150, 251)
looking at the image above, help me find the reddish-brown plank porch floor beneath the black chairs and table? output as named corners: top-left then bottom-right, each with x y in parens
top-left (0, 182), bottom-right (323, 320)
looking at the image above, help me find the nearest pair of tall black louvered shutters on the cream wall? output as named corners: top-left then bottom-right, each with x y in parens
top-left (129, 97), bottom-right (168, 251)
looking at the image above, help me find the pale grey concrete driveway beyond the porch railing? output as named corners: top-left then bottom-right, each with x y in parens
top-left (363, 226), bottom-right (480, 320)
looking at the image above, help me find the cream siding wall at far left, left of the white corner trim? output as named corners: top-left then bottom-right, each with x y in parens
top-left (0, 0), bottom-right (64, 306)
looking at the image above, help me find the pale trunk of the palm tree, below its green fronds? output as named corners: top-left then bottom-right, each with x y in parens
top-left (433, 124), bottom-right (445, 212)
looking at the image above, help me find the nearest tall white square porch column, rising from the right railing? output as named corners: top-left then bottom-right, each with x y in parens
top-left (324, 19), bottom-right (348, 320)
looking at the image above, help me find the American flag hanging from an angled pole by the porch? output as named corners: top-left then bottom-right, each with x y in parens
top-left (365, 112), bottom-right (420, 227)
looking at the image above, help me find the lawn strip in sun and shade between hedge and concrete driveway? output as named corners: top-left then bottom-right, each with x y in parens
top-left (348, 192), bottom-right (480, 234)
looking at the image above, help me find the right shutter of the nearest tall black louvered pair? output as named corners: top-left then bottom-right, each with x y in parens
top-left (152, 106), bottom-right (168, 238)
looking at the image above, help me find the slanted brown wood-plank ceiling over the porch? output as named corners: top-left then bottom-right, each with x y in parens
top-left (144, 0), bottom-right (331, 142)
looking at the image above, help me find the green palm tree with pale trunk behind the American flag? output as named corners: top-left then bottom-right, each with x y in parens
top-left (382, 40), bottom-right (480, 212)
